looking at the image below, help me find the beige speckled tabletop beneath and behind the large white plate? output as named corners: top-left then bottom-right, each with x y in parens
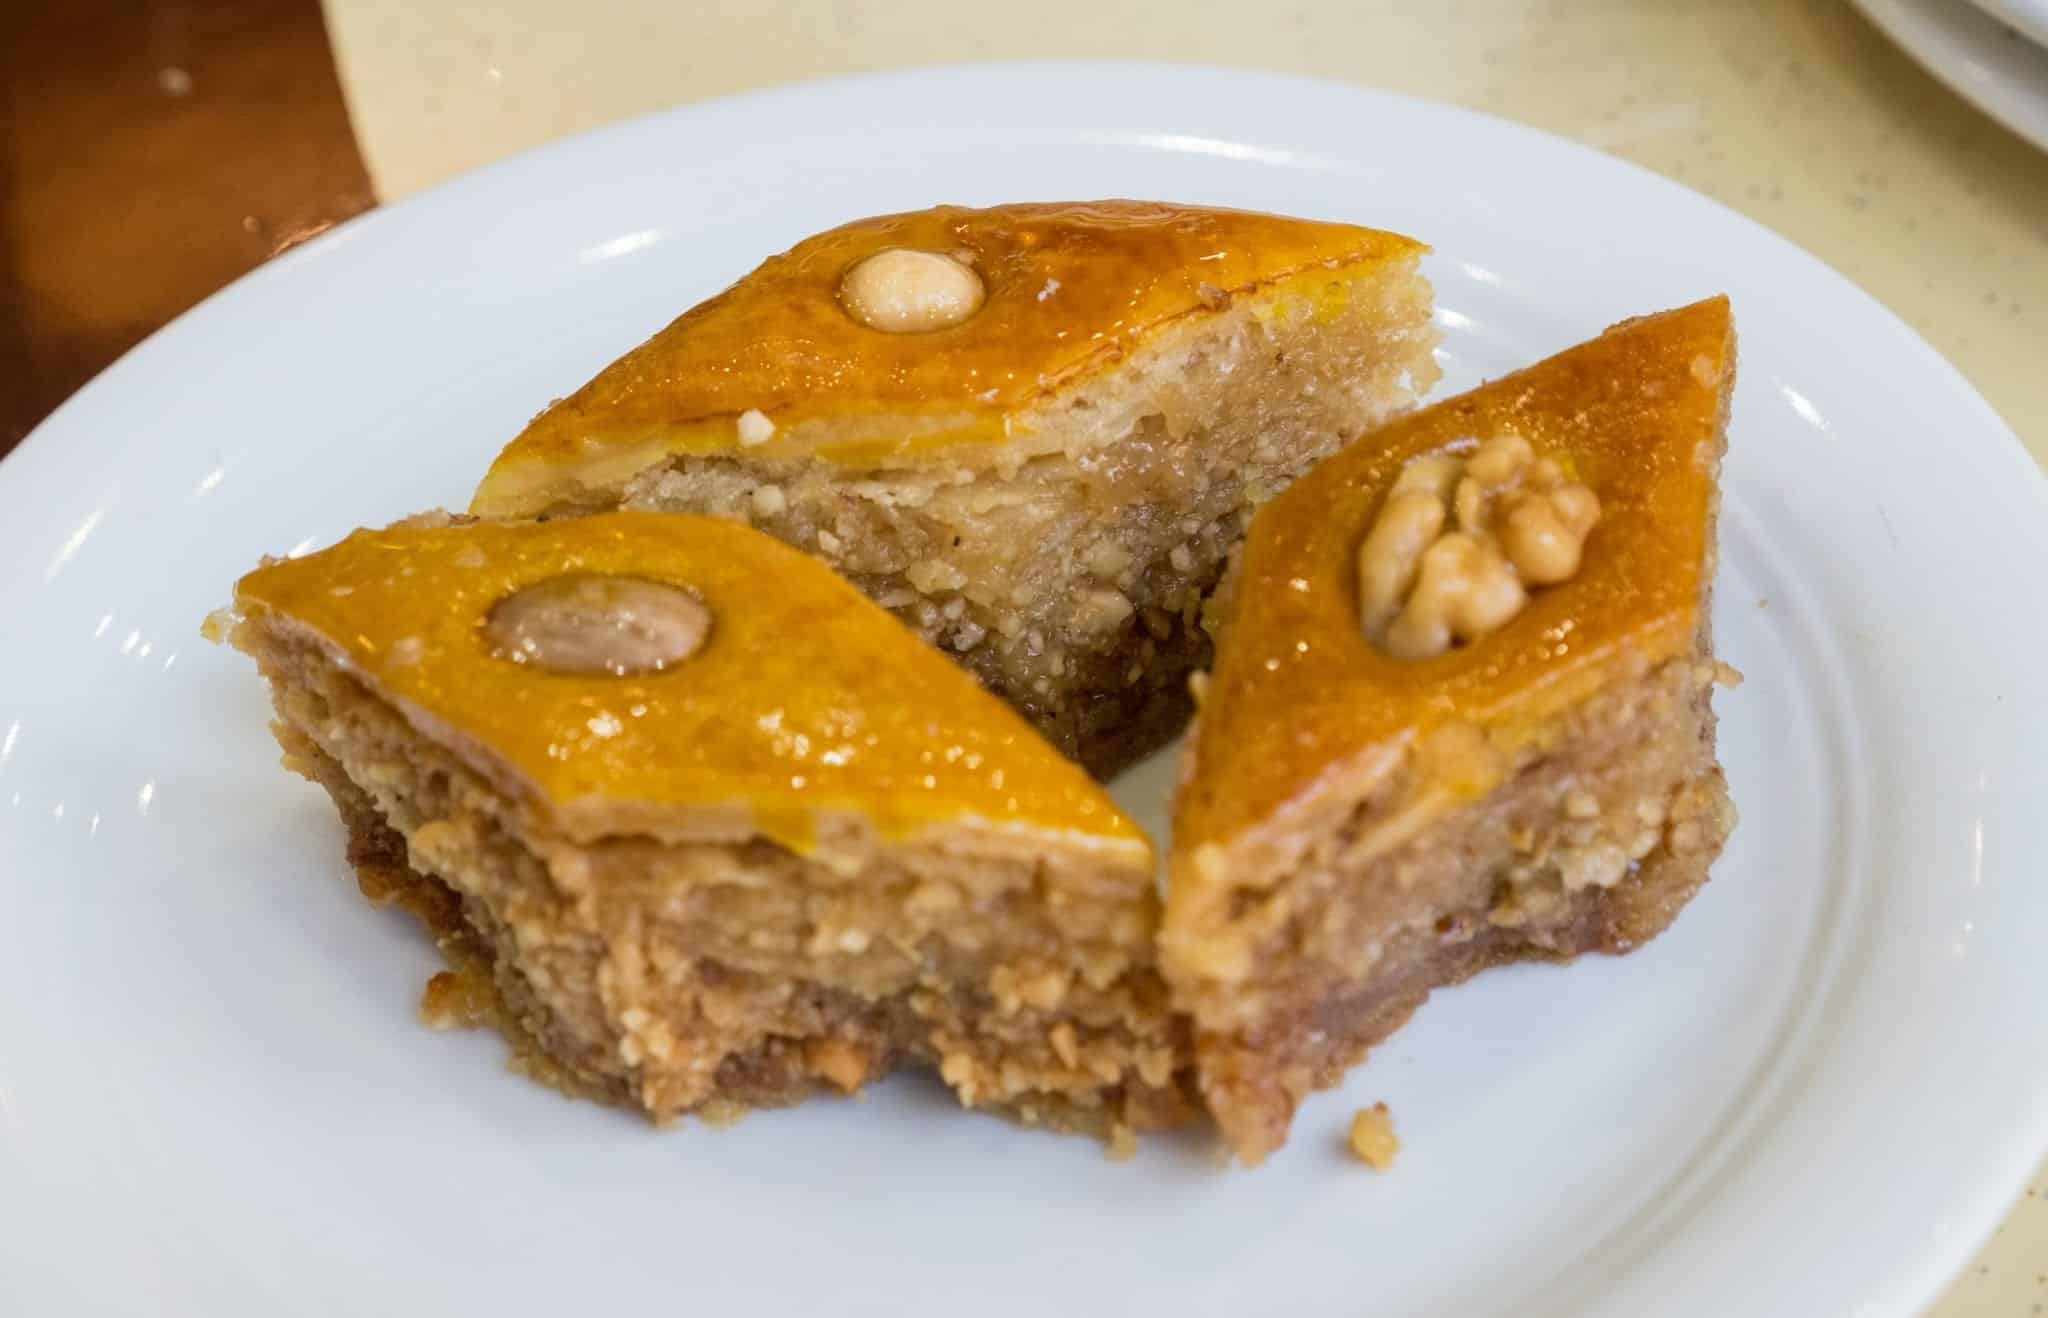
top-left (326, 0), bottom-right (2048, 1318)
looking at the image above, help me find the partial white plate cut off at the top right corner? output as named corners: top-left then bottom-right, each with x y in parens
top-left (1855, 0), bottom-right (2048, 151)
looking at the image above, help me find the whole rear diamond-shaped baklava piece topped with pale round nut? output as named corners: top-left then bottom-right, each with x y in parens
top-left (471, 201), bottom-right (1438, 776)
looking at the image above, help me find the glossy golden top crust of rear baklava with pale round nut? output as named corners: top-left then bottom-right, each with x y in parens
top-left (471, 201), bottom-right (1423, 516)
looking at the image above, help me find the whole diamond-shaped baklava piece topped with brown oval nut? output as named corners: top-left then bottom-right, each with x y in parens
top-left (231, 514), bottom-right (1194, 1138)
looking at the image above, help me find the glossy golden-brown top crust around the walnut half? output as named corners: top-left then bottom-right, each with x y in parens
top-left (1174, 297), bottom-right (1735, 855)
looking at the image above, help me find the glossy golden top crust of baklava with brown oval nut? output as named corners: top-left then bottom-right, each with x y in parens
top-left (236, 512), bottom-right (1151, 859)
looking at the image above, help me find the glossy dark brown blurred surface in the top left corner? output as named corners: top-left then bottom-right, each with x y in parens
top-left (0, 0), bottom-right (373, 452)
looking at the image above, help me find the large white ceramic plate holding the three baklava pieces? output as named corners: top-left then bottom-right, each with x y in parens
top-left (0, 65), bottom-right (2048, 1318)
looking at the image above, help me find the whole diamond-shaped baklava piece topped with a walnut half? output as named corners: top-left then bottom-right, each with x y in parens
top-left (1161, 299), bottom-right (1735, 1162)
